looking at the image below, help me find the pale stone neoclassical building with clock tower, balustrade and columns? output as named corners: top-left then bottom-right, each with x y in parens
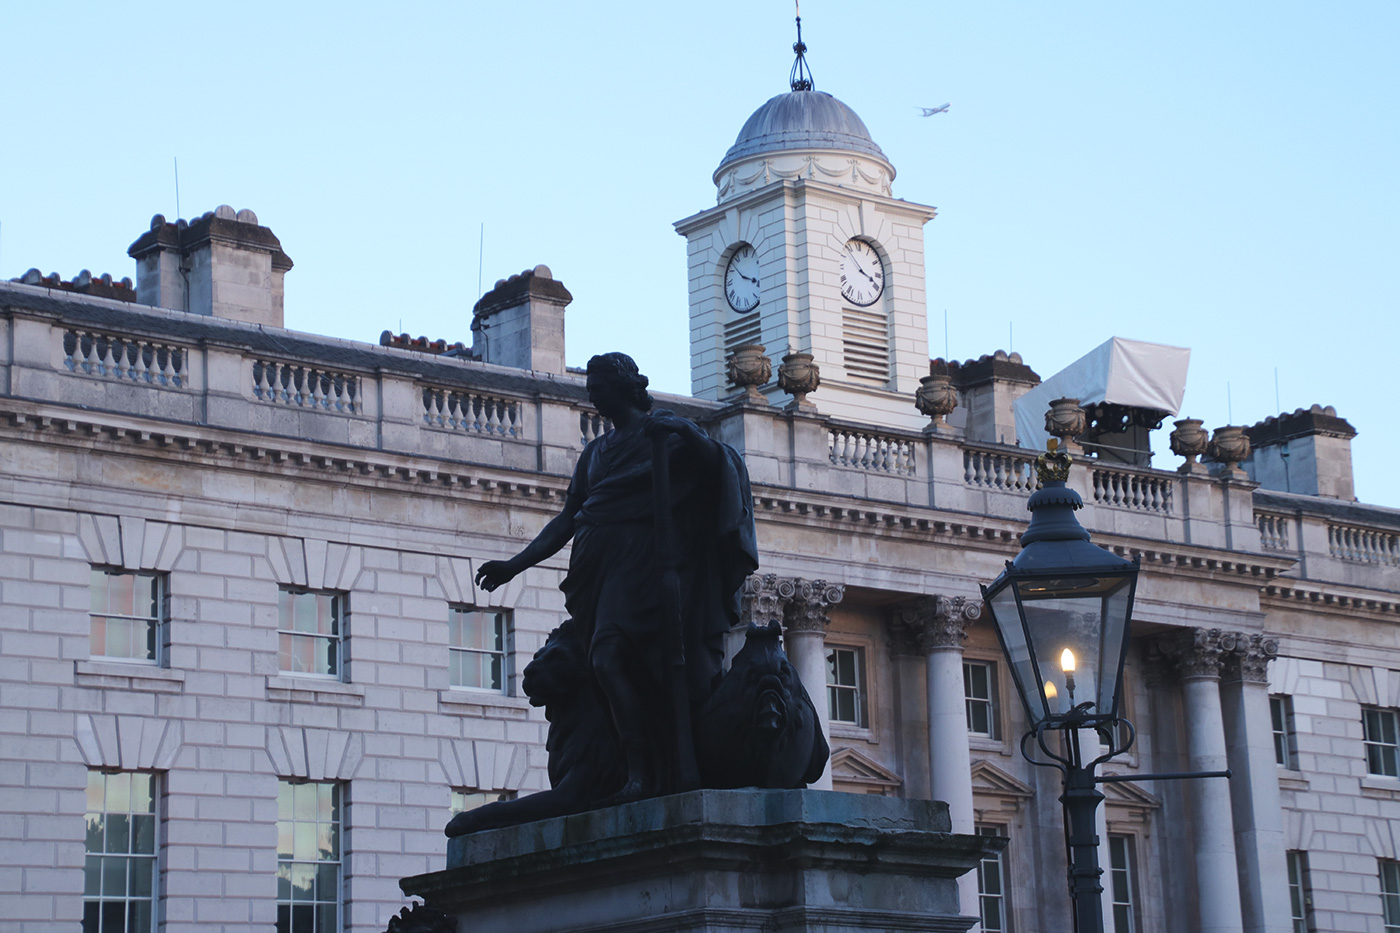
top-left (0, 65), bottom-right (1400, 933)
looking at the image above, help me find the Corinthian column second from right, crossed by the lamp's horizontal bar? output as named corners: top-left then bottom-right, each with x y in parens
top-left (1165, 629), bottom-right (1254, 933)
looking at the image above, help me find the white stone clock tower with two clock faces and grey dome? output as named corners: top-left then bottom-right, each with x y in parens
top-left (676, 25), bottom-right (934, 429)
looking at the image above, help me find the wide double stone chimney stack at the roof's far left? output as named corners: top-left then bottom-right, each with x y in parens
top-left (126, 205), bottom-right (291, 328)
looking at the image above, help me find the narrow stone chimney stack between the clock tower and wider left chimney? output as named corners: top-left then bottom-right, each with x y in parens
top-left (472, 265), bottom-right (574, 374)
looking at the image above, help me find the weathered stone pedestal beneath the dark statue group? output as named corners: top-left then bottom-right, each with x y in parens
top-left (399, 790), bottom-right (1004, 933)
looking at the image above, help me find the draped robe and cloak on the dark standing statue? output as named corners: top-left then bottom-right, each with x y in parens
top-left (560, 412), bottom-right (759, 703)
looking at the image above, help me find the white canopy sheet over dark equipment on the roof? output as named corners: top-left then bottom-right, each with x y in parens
top-left (1012, 338), bottom-right (1191, 450)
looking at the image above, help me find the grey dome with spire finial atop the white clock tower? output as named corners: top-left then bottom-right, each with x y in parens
top-left (714, 26), bottom-right (895, 203)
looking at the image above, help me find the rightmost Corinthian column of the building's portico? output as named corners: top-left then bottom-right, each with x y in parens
top-left (1221, 635), bottom-right (1292, 933)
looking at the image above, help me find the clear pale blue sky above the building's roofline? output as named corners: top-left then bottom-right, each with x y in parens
top-left (0, 0), bottom-right (1400, 507)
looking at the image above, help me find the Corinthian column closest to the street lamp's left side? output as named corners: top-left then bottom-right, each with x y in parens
top-left (895, 595), bottom-right (981, 916)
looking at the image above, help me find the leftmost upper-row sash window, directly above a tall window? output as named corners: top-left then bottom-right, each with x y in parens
top-left (88, 567), bottom-right (168, 664)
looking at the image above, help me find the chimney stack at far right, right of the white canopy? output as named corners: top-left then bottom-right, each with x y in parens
top-left (1240, 405), bottom-right (1357, 502)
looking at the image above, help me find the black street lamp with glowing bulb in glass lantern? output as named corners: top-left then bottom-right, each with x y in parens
top-left (981, 438), bottom-right (1138, 933)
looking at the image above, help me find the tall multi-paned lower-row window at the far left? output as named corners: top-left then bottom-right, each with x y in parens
top-left (83, 770), bottom-right (157, 933)
